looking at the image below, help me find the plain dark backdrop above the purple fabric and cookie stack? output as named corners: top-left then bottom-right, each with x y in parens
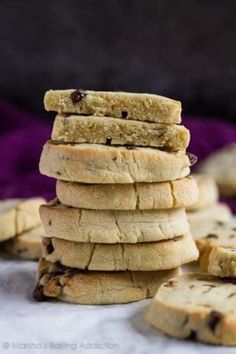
top-left (0, 0), bottom-right (236, 120)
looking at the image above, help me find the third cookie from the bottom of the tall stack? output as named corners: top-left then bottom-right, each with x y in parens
top-left (40, 200), bottom-right (189, 243)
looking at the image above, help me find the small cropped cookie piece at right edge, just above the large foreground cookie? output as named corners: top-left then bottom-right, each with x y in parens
top-left (207, 245), bottom-right (236, 278)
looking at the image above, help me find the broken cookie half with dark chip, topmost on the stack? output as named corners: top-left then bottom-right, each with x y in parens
top-left (44, 89), bottom-right (181, 123)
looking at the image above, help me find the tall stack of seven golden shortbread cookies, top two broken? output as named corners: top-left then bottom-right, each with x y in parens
top-left (34, 90), bottom-right (198, 304)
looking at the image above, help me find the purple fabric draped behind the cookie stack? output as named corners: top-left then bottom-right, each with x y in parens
top-left (0, 100), bottom-right (236, 212)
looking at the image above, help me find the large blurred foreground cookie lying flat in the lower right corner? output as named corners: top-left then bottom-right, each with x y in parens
top-left (146, 273), bottom-right (236, 346)
